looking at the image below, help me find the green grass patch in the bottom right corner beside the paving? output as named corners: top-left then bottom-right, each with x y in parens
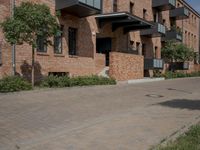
top-left (155, 125), bottom-right (200, 150)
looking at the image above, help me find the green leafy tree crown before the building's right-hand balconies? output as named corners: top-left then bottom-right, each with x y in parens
top-left (162, 41), bottom-right (194, 62)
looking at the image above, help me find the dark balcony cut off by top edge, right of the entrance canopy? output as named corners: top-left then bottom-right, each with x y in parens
top-left (152, 0), bottom-right (176, 11)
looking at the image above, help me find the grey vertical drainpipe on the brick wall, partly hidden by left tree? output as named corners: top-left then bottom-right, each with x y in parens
top-left (11, 0), bottom-right (16, 76)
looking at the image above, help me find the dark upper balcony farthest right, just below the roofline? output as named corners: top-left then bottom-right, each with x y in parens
top-left (169, 7), bottom-right (189, 20)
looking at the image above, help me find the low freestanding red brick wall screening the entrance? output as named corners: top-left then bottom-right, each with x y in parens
top-left (109, 52), bottom-right (144, 81)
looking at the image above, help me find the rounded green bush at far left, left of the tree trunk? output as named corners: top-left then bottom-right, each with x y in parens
top-left (0, 76), bottom-right (32, 93)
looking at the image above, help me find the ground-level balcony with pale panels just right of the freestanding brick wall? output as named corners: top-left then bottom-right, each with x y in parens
top-left (144, 58), bottom-right (164, 70)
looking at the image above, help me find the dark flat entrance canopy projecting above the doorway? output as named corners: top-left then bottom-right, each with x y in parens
top-left (96, 12), bottom-right (153, 33)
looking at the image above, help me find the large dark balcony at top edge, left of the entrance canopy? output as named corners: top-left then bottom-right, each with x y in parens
top-left (56, 0), bottom-right (102, 17)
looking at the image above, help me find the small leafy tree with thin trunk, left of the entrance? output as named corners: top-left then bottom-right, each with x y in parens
top-left (1, 2), bottom-right (59, 86)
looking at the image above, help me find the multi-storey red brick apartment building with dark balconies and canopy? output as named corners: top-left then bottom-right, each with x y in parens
top-left (0, 0), bottom-right (200, 80)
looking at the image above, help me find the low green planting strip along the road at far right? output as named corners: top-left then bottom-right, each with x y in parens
top-left (154, 71), bottom-right (200, 79)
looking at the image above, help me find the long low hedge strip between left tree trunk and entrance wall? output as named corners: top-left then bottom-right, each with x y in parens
top-left (41, 75), bottom-right (116, 88)
